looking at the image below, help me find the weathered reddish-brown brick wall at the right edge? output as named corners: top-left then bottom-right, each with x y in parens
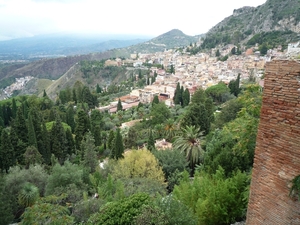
top-left (246, 60), bottom-right (300, 225)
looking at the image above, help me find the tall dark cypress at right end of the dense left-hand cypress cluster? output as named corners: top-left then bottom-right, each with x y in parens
top-left (75, 109), bottom-right (90, 150)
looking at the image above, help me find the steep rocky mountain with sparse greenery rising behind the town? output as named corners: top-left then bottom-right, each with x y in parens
top-left (202, 0), bottom-right (300, 48)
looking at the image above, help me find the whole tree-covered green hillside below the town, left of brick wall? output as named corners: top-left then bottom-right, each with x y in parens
top-left (0, 71), bottom-right (261, 224)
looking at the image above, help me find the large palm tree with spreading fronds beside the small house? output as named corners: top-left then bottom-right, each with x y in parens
top-left (173, 126), bottom-right (204, 171)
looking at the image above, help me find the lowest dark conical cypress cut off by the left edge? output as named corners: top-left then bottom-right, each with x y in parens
top-left (0, 129), bottom-right (16, 172)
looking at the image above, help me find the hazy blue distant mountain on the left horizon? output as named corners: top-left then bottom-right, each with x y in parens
top-left (0, 34), bottom-right (150, 60)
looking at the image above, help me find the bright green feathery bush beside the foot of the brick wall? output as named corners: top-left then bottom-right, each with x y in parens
top-left (173, 167), bottom-right (249, 225)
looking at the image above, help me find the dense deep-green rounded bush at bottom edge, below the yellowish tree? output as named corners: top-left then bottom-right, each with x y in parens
top-left (87, 193), bottom-right (150, 225)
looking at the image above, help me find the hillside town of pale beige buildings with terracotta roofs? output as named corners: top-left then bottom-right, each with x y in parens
top-left (100, 43), bottom-right (292, 113)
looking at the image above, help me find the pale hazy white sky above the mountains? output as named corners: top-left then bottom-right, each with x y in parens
top-left (0, 0), bottom-right (266, 40)
